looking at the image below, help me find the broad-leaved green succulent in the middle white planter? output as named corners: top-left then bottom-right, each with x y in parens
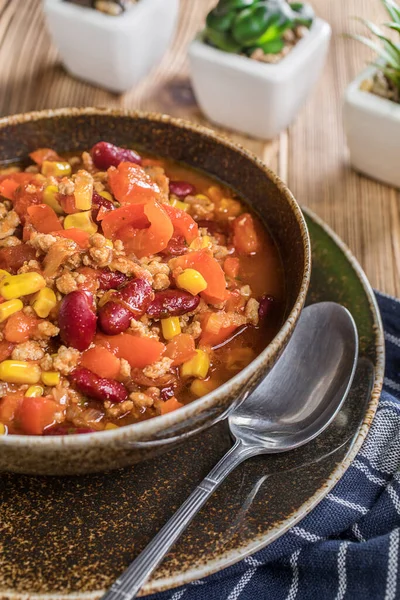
top-left (204, 0), bottom-right (314, 55)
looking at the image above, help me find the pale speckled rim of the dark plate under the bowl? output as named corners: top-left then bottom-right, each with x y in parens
top-left (0, 208), bottom-right (385, 600)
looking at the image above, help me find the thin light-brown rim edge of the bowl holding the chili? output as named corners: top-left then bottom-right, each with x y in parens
top-left (0, 107), bottom-right (312, 451)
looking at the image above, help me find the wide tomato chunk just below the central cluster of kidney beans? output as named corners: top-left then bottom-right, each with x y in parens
top-left (94, 333), bottom-right (165, 369)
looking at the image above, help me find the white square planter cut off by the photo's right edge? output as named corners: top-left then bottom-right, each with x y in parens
top-left (344, 68), bottom-right (400, 187)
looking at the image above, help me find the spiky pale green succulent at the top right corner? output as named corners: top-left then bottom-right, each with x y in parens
top-left (350, 0), bottom-right (400, 94)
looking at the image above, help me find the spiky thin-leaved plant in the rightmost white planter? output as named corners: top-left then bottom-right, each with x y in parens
top-left (349, 0), bottom-right (400, 103)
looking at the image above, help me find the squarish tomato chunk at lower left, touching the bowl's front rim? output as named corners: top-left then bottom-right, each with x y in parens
top-left (16, 396), bottom-right (60, 435)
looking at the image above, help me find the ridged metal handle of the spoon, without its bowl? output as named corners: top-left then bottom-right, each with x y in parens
top-left (101, 441), bottom-right (252, 600)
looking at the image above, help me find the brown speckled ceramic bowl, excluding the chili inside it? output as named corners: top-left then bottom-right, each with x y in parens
top-left (0, 108), bottom-right (311, 475)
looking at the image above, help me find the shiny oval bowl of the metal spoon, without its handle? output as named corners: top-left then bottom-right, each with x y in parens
top-left (229, 302), bottom-right (358, 453)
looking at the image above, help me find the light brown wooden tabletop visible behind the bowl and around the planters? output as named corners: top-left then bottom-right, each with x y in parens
top-left (0, 0), bottom-right (400, 296)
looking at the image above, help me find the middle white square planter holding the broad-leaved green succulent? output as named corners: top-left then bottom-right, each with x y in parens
top-left (189, 19), bottom-right (331, 139)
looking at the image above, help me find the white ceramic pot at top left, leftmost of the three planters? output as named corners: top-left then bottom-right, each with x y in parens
top-left (44, 0), bottom-right (179, 93)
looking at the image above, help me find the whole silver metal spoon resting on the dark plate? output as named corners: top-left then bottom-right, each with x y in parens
top-left (102, 302), bottom-right (358, 600)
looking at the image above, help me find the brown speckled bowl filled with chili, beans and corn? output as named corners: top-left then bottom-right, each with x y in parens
top-left (0, 108), bottom-right (311, 475)
